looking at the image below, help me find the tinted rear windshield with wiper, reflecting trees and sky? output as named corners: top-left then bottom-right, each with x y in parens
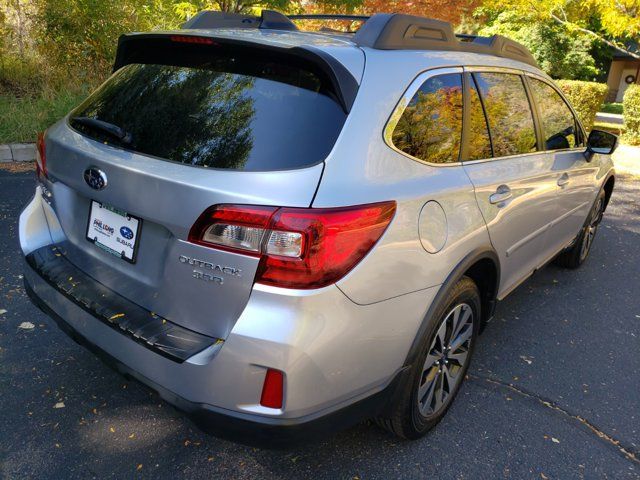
top-left (70, 54), bottom-right (346, 171)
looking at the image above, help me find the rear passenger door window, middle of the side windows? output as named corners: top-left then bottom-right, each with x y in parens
top-left (473, 73), bottom-right (537, 157)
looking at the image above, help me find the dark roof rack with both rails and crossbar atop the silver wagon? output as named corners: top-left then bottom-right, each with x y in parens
top-left (182, 10), bottom-right (538, 67)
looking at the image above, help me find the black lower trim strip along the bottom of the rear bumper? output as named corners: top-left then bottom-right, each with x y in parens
top-left (24, 272), bottom-right (406, 447)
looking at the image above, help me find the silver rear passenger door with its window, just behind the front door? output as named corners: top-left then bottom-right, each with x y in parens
top-left (464, 70), bottom-right (557, 297)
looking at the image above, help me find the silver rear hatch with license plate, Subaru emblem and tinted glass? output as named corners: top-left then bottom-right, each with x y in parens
top-left (46, 35), bottom-right (358, 338)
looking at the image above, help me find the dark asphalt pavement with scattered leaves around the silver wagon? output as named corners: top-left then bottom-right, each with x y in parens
top-left (0, 167), bottom-right (640, 479)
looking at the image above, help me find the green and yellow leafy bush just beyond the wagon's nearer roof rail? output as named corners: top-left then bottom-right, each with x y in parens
top-left (479, 11), bottom-right (599, 80)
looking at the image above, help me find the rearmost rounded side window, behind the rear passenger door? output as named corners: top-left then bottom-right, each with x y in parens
top-left (392, 73), bottom-right (462, 163)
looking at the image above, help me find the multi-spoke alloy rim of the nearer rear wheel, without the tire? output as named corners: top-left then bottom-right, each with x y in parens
top-left (418, 303), bottom-right (474, 417)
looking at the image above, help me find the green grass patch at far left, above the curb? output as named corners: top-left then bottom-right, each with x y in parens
top-left (0, 89), bottom-right (87, 144)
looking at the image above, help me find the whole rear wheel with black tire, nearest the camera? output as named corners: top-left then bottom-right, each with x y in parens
top-left (376, 277), bottom-right (481, 439)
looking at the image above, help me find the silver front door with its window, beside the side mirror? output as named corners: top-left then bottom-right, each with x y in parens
top-left (527, 76), bottom-right (598, 251)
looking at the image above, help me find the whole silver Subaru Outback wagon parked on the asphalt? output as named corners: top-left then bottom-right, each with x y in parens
top-left (20, 11), bottom-right (616, 442)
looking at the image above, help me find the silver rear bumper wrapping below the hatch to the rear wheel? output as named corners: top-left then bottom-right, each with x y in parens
top-left (20, 189), bottom-right (437, 444)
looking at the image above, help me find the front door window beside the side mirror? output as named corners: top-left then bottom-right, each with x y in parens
top-left (529, 78), bottom-right (580, 150)
